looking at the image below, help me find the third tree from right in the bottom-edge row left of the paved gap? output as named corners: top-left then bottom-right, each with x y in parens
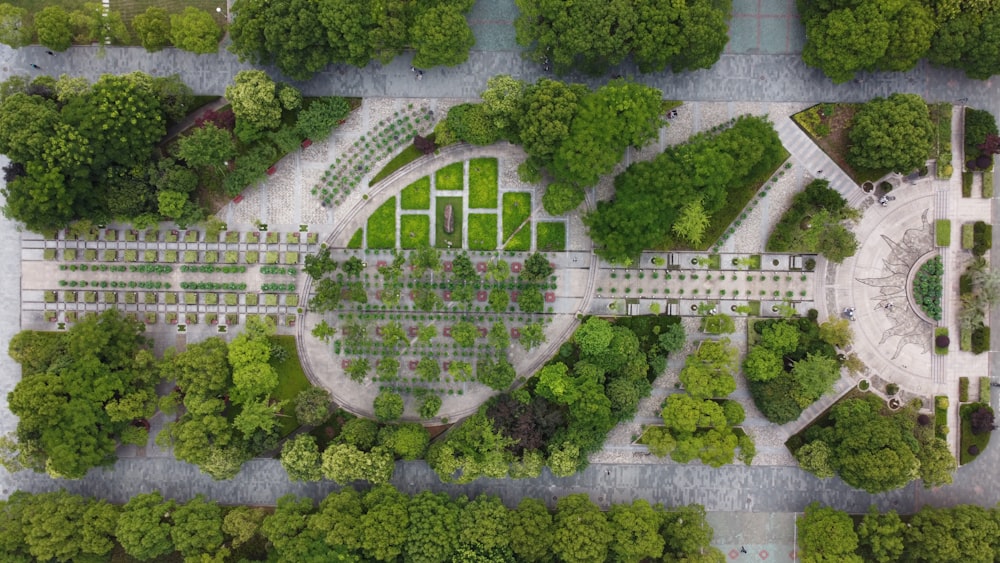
top-left (551, 494), bottom-right (612, 562)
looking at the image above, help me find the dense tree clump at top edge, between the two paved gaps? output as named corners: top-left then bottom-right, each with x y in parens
top-left (514, 0), bottom-right (730, 75)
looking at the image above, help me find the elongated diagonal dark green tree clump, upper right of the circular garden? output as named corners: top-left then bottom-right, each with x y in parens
top-left (584, 116), bottom-right (784, 262)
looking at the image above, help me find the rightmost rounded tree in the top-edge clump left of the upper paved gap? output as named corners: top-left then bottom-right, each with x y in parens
top-left (411, 4), bottom-right (476, 67)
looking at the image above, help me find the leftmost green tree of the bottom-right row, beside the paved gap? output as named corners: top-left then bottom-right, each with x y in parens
top-left (795, 502), bottom-right (861, 563)
